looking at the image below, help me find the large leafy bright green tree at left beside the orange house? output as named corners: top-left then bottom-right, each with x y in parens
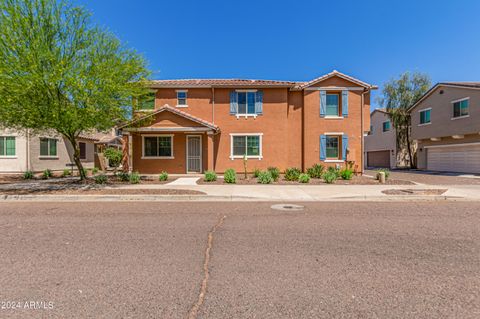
top-left (0, 0), bottom-right (149, 179)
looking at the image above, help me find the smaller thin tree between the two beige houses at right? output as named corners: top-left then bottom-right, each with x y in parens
top-left (379, 72), bottom-right (431, 168)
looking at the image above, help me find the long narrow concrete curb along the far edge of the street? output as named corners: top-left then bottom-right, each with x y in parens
top-left (0, 195), bottom-right (470, 202)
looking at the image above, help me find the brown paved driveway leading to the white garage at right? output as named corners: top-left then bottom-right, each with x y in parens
top-left (365, 170), bottom-right (480, 185)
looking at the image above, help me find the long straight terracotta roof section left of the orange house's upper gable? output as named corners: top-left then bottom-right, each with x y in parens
top-left (150, 79), bottom-right (303, 88)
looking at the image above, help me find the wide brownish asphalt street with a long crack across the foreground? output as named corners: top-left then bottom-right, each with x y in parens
top-left (0, 201), bottom-right (480, 318)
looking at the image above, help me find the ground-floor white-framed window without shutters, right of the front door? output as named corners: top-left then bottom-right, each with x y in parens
top-left (230, 133), bottom-right (263, 160)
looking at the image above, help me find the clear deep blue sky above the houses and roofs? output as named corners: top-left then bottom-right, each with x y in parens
top-left (77, 0), bottom-right (480, 107)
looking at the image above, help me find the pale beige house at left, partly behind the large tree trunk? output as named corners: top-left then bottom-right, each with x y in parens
top-left (0, 129), bottom-right (121, 173)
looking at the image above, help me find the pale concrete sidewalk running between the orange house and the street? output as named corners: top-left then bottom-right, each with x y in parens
top-left (0, 184), bottom-right (480, 201)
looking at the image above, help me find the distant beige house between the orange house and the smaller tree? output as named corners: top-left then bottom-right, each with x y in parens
top-left (364, 109), bottom-right (408, 168)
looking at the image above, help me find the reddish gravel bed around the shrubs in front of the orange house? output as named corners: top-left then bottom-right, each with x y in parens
top-left (197, 174), bottom-right (414, 185)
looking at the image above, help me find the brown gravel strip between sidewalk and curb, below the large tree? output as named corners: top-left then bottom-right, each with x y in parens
top-left (0, 188), bottom-right (205, 195)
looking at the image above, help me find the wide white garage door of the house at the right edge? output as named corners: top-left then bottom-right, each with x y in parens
top-left (427, 145), bottom-right (480, 173)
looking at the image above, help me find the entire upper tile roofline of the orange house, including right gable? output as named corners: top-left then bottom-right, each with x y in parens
top-left (145, 70), bottom-right (377, 90)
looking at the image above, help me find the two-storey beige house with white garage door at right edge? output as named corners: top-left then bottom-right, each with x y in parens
top-left (410, 82), bottom-right (480, 173)
